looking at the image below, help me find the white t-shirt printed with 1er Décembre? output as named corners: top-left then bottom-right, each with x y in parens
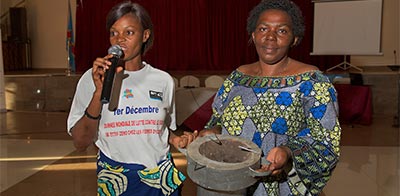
top-left (67, 62), bottom-right (176, 168)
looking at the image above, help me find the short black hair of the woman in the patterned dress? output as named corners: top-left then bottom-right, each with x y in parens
top-left (247, 0), bottom-right (306, 44)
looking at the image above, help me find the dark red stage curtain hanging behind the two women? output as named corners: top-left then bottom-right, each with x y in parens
top-left (75, 0), bottom-right (343, 72)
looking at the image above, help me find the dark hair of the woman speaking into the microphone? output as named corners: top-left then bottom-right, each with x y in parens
top-left (106, 1), bottom-right (154, 54)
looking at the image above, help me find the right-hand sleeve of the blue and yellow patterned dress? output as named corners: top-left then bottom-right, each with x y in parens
top-left (287, 76), bottom-right (341, 195)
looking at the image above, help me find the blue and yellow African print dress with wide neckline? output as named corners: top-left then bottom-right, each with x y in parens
top-left (206, 70), bottom-right (341, 196)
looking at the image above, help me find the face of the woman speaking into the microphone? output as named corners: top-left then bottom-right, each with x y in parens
top-left (110, 14), bottom-right (150, 61)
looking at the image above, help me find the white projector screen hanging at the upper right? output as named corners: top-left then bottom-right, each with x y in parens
top-left (311, 0), bottom-right (382, 55)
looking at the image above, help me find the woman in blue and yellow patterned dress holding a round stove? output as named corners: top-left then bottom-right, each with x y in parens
top-left (181, 0), bottom-right (341, 196)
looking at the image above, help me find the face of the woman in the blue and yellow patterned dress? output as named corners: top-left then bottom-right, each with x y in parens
top-left (252, 9), bottom-right (297, 64)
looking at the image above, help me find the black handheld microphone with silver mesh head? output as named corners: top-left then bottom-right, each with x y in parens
top-left (100, 45), bottom-right (123, 104)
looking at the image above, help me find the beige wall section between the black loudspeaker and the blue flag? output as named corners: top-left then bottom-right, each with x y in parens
top-left (26, 0), bottom-right (76, 69)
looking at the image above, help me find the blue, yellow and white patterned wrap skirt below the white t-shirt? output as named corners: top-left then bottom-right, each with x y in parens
top-left (97, 151), bottom-right (186, 196)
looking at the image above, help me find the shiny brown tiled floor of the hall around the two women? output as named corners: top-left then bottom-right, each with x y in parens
top-left (0, 112), bottom-right (400, 196)
